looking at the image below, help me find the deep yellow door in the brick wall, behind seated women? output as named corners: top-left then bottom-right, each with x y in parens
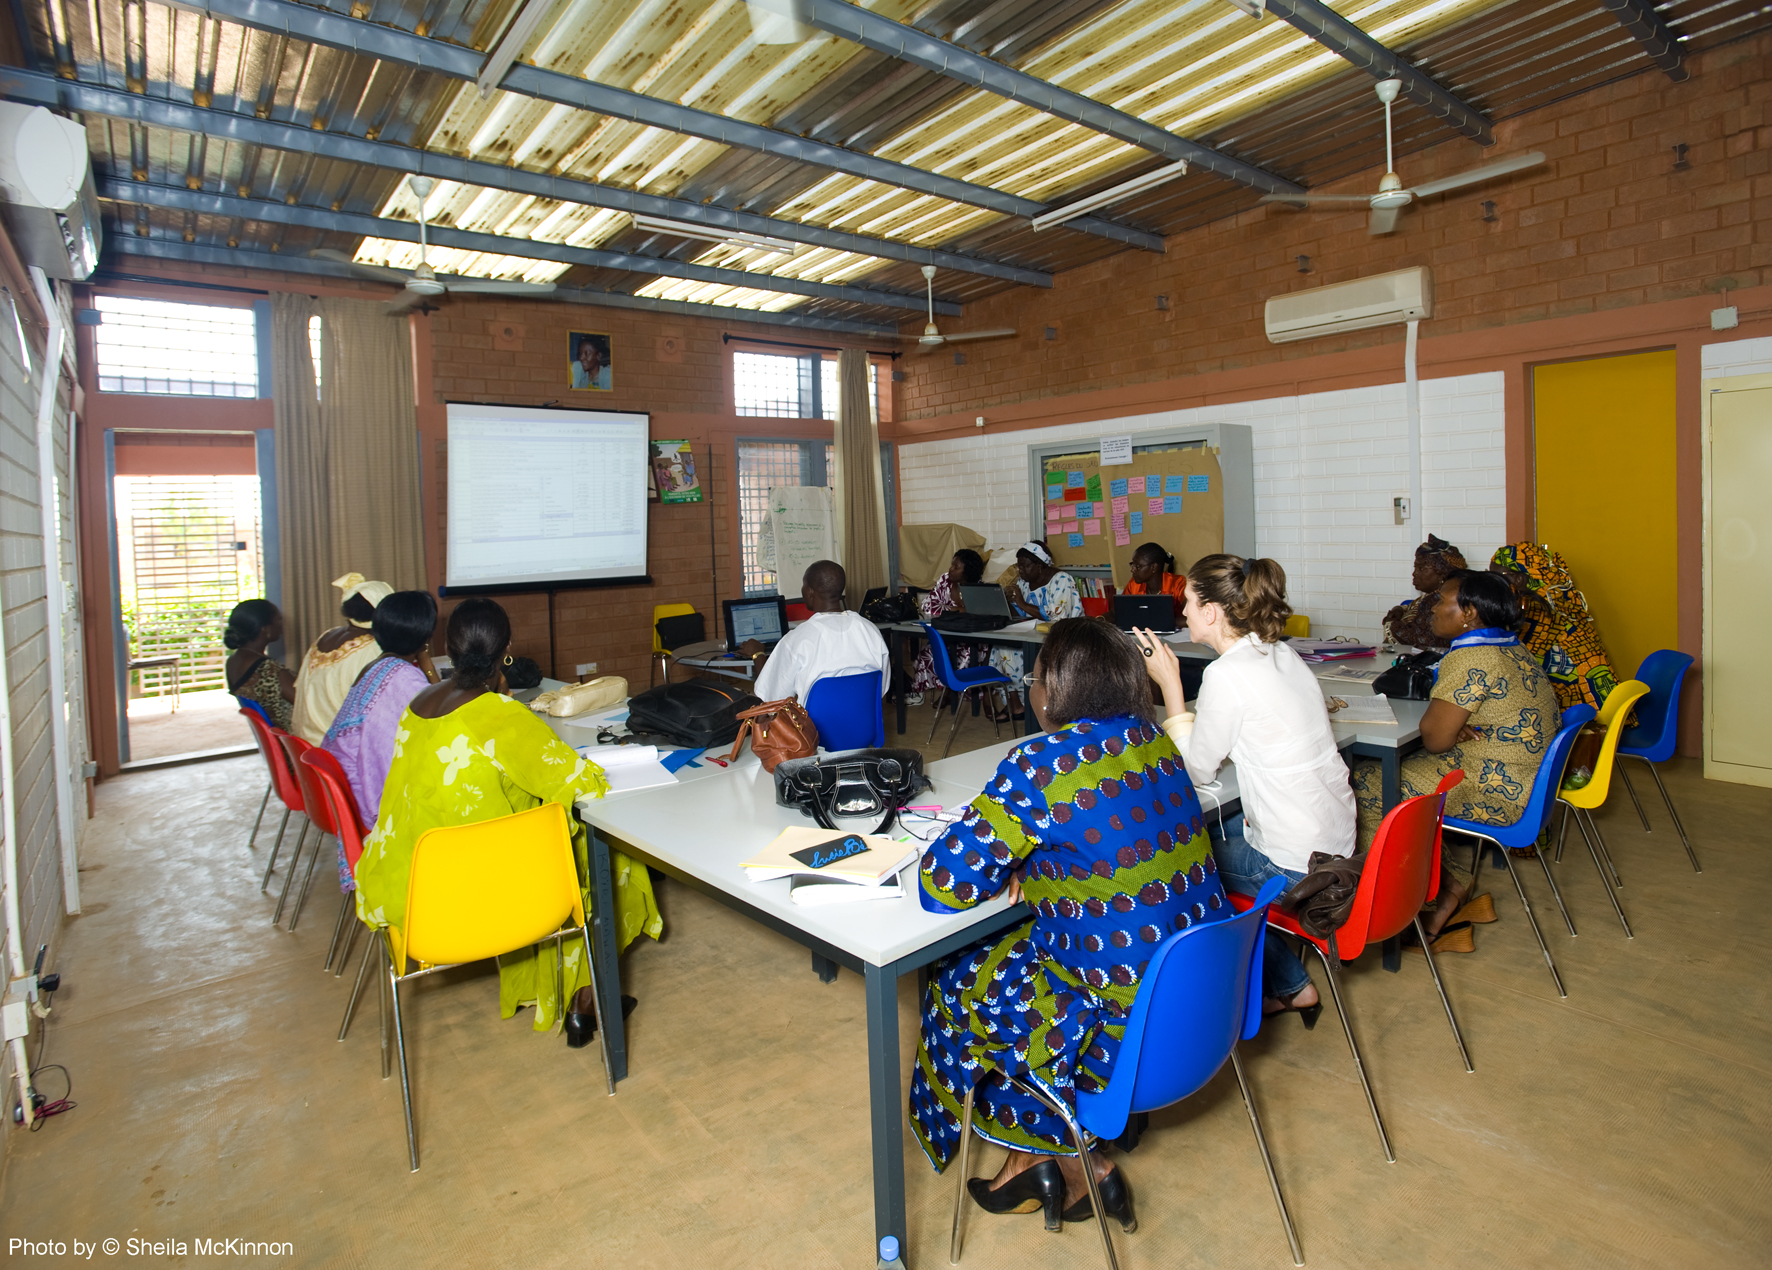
top-left (1533, 351), bottom-right (1680, 680)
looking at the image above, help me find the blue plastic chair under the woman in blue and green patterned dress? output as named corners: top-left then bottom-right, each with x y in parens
top-left (948, 877), bottom-right (1304, 1270)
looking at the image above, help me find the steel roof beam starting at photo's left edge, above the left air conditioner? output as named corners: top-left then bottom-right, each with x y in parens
top-left (0, 66), bottom-right (1053, 287)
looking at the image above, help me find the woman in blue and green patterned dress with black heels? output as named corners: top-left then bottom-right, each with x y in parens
top-left (909, 618), bottom-right (1230, 1229)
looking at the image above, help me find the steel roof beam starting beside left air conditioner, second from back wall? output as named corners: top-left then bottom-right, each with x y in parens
top-left (99, 177), bottom-right (960, 317)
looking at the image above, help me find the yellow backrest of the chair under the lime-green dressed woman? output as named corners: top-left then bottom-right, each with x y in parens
top-left (397, 802), bottom-right (585, 965)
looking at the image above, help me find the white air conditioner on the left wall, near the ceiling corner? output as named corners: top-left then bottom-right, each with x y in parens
top-left (0, 101), bottom-right (105, 282)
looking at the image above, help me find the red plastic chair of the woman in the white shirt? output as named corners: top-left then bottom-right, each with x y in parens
top-left (1230, 772), bottom-right (1476, 1164)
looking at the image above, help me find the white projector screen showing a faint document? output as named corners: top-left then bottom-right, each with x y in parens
top-left (445, 402), bottom-right (650, 592)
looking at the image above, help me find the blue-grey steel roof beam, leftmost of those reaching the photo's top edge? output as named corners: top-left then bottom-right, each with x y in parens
top-left (166, 0), bottom-right (1162, 252)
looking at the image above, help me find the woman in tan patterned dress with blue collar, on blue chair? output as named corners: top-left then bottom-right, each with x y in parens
top-left (1354, 570), bottom-right (1563, 951)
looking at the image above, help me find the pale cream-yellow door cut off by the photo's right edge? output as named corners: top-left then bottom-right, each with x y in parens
top-left (1705, 376), bottom-right (1772, 785)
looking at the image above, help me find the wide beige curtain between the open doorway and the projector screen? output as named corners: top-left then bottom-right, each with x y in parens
top-left (271, 296), bottom-right (425, 668)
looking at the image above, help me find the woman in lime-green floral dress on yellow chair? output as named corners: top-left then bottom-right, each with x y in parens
top-left (356, 599), bottom-right (665, 1043)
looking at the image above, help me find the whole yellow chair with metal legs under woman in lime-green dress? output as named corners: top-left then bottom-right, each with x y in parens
top-left (381, 802), bottom-right (615, 1173)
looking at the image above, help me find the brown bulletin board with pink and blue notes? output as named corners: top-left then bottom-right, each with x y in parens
top-left (1030, 425), bottom-right (1255, 586)
